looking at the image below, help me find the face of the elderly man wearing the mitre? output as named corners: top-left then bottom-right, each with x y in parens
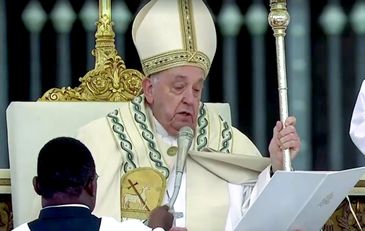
top-left (143, 66), bottom-right (204, 136)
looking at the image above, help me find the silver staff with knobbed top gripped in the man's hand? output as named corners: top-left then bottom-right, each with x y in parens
top-left (268, 0), bottom-right (292, 171)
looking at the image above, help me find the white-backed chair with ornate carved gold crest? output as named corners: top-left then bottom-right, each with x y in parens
top-left (5, 1), bottom-right (230, 226)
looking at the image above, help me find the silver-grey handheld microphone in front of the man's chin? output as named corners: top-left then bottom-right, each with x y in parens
top-left (168, 126), bottom-right (194, 209)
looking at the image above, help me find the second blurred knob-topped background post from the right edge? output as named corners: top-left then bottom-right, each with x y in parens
top-left (320, 1), bottom-right (346, 170)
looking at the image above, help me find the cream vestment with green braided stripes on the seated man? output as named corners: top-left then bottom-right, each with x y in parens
top-left (78, 96), bottom-right (270, 231)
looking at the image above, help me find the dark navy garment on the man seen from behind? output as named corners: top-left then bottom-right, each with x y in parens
top-left (28, 206), bottom-right (101, 231)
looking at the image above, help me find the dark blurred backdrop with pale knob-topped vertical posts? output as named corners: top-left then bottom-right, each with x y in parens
top-left (0, 0), bottom-right (365, 170)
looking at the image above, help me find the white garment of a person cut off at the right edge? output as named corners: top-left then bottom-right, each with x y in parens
top-left (350, 81), bottom-right (365, 154)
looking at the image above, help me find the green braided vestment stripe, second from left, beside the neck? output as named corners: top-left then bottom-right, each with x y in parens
top-left (131, 96), bottom-right (170, 178)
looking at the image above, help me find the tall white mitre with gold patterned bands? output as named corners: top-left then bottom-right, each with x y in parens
top-left (132, 0), bottom-right (217, 76)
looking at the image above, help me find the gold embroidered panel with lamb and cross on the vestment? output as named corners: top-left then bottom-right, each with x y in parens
top-left (121, 167), bottom-right (166, 220)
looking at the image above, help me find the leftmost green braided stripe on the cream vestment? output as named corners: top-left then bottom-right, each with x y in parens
top-left (107, 110), bottom-right (137, 173)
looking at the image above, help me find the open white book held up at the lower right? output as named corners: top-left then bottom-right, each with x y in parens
top-left (235, 167), bottom-right (365, 231)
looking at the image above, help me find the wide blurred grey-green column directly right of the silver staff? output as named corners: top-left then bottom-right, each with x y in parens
top-left (286, 0), bottom-right (312, 170)
